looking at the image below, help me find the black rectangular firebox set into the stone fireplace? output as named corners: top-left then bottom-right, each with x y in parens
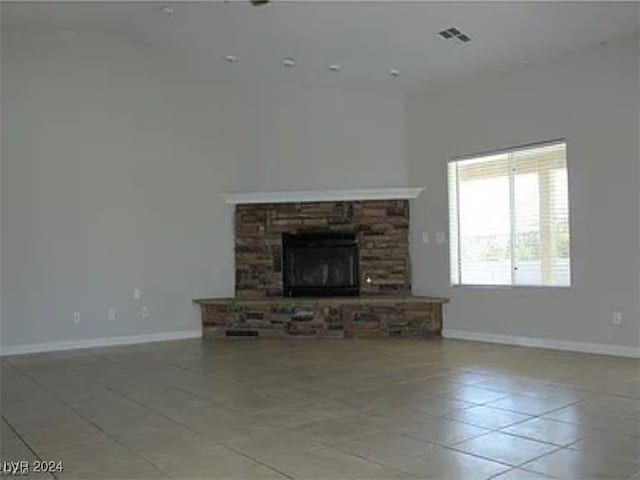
top-left (282, 232), bottom-right (360, 297)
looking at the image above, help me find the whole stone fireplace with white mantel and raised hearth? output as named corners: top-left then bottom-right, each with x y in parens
top-left (195, 188), bottom-right (447, 338)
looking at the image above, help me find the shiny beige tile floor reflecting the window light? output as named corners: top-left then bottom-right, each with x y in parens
top-left (0, 339), bottom-right (640, 480)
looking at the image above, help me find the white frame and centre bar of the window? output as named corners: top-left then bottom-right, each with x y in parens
top-left (446, 138), bottom-right (574, 290)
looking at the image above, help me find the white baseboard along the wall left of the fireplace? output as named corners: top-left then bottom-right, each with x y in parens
top-left (0, 329), bottom-right (202, 356)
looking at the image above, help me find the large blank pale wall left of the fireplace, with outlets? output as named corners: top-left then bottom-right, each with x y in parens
top-left (2, 32), bottom-right (242, 345)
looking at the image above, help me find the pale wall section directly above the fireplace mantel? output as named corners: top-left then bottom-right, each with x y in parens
top-left (232, 86), bottom-right (408, 191)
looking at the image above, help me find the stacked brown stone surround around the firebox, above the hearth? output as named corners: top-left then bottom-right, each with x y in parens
top-left (235, 200), bottom-right (411, 297)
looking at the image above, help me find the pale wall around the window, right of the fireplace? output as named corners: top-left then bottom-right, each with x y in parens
top-left (406, 33), bottom-right (640, 347)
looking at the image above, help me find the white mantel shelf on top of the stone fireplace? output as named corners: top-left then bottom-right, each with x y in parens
top-left (222, 187), bottom-right (424, 205)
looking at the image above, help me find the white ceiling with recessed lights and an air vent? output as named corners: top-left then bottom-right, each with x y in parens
top-left (1, 0), bottom-right (640, 92)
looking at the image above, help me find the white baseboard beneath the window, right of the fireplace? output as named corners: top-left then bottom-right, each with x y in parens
top-left (442, 328), bottom-right (640, 358)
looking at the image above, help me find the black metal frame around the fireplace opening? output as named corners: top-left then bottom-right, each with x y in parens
top-left (282, 232), bottom-right (360, 297)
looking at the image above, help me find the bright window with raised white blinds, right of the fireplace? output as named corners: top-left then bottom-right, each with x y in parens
top-left (449, 142), bottom-right (571, 287)
